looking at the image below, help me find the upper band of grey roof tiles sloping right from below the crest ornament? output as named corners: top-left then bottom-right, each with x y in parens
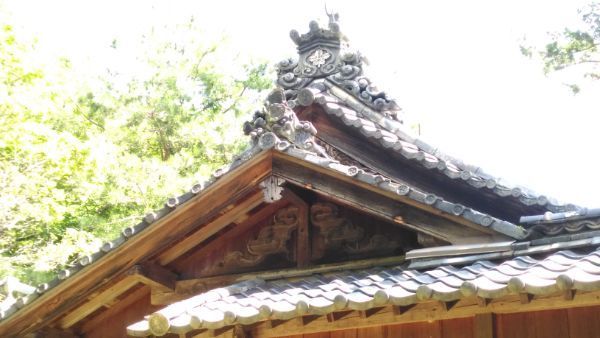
top-left (298, 80), bottom-right (580, 212)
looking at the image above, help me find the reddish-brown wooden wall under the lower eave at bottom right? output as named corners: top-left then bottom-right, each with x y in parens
top-left (281, 306), bottom-right (600, 338)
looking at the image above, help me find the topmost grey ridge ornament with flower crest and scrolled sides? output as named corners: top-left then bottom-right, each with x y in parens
top-left (277, 14), bottom-right (400, 116)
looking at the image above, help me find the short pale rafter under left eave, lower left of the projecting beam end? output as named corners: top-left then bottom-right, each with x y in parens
top-left (59, 274), bottom-right (139, 329)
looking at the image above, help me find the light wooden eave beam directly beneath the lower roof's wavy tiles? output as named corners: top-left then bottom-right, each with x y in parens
top-left (250, 291), bottom-right (600, 338)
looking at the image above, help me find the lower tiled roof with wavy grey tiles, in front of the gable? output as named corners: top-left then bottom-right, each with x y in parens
top-left (128, 244), bottom-right (600, 337)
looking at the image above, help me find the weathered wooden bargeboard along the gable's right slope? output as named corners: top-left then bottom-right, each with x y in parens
top-left (273, 154), bottom-right (492, 244)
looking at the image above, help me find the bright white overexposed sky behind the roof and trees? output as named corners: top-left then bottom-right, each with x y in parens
top-left (5, 0), bottom-right (600, 207)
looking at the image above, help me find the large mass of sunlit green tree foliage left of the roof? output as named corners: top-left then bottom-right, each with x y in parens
top-left (0, 16), bottom-right (271, 283)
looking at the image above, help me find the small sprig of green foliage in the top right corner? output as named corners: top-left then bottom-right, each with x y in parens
top-left (521, 2), bottom-right (600, 93)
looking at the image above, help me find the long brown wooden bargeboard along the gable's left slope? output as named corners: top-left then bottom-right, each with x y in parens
top-left (0, 151), bottom-right (273, 337)
